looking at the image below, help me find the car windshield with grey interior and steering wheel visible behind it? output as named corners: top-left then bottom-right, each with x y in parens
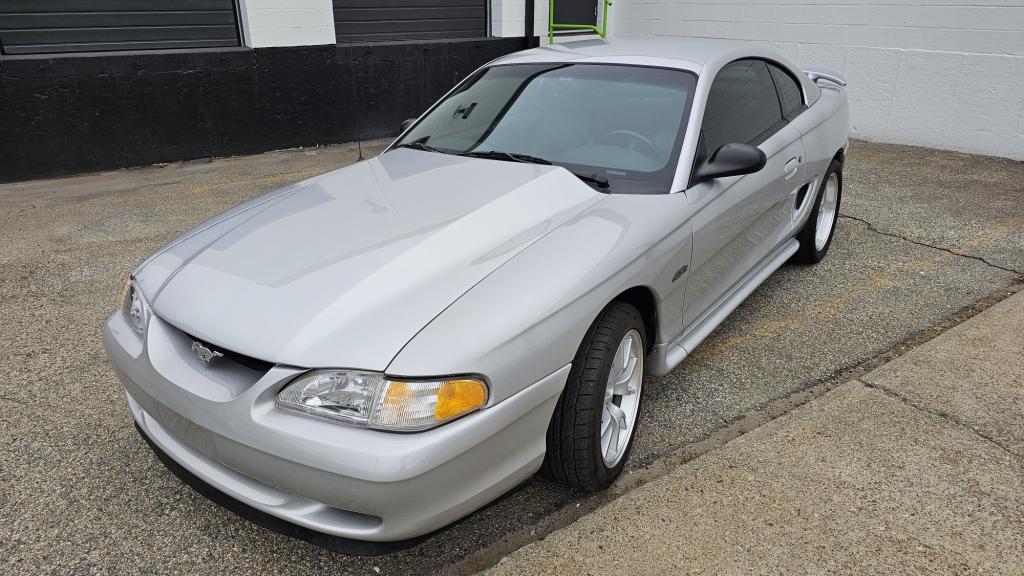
top-left (396, 64), bottom-right (696, 193)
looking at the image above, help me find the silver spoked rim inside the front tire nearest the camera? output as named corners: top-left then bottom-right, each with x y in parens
top-left (598, 330), bottom-right (644, 468)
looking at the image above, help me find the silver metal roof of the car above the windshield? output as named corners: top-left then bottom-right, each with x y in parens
top-left (493, 37), bottom-right (761, 72)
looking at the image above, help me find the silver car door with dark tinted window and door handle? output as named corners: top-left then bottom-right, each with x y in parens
top-left (683, 58), bottom-right (803, 327)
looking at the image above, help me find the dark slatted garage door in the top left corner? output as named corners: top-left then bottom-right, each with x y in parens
top-left (0, 0), bottom-right (241, 54)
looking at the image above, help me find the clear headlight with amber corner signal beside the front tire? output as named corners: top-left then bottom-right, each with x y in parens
top-left (276, 370), bottom-right (487, 431)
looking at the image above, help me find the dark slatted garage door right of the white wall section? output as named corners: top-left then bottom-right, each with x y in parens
top-left (331, 0), bottom-right (487, 43)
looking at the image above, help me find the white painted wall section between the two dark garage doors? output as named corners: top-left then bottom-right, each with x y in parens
top-left (239, 0), bottom-right (335, 48)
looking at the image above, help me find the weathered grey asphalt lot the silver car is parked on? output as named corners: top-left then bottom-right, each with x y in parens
top-left (0, 141), bottom-right (1024, 575)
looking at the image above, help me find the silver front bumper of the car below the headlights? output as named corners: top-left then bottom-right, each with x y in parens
top-left (103, 314), bottom-right (568, 542)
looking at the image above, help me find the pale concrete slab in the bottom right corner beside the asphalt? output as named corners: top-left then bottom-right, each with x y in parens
top-left (487, 292), bottom-right (1024, 576)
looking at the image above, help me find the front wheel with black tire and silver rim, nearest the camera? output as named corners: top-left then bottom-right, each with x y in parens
top-left (541, 302), bottom-right (647, 492)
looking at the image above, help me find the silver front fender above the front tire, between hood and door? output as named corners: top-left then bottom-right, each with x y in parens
top-left (387, 194), bottom-right (691, 404)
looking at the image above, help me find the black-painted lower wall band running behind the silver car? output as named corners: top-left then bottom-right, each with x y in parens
top-left (0, 38), bottom-right (525, 181)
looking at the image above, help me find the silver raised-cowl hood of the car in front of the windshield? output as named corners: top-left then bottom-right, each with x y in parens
top-left (137, 150), bottom-right (604, 370)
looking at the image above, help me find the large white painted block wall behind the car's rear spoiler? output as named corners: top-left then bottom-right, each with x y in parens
top-left (606, 0), bottom-right (1024, 160)
